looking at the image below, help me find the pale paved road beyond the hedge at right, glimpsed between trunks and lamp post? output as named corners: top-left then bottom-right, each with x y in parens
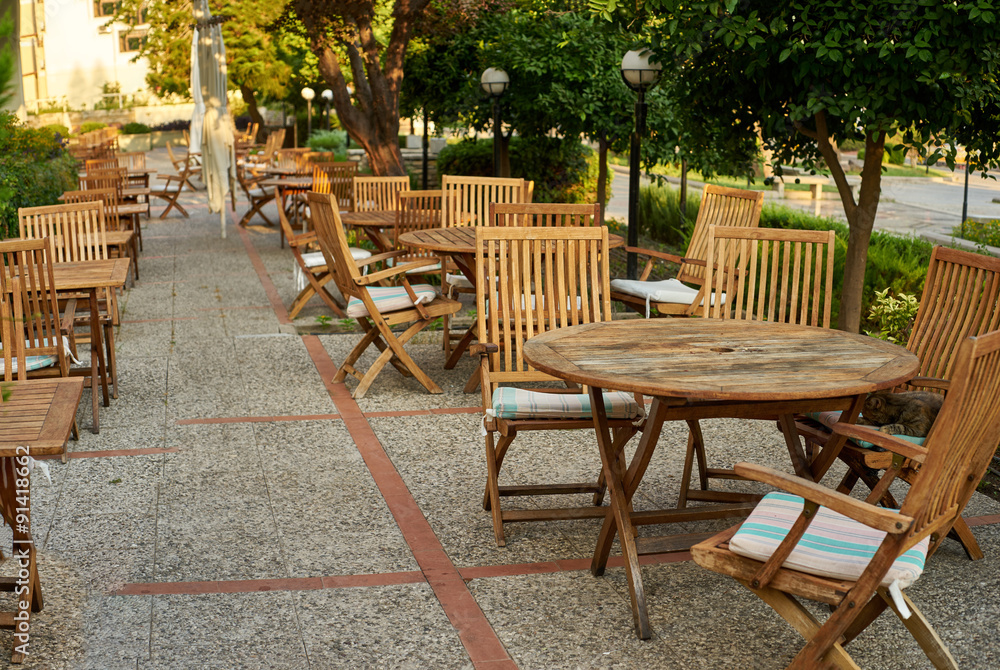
top-left (607, 166), bottom-right (1000, 243)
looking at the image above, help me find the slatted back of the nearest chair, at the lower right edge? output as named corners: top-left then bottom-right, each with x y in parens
top-left (900, 331), bottom-right (1000, 548)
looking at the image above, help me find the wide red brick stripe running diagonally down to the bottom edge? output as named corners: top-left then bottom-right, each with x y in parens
top-left (302, 335), bottom-right (513, 667)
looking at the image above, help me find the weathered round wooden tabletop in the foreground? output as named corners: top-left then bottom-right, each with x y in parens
top-left (524, 319), bottom-right (917, 401)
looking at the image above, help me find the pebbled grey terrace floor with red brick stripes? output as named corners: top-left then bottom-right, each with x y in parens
top-left (0, 150), bottom-right (1000, 670)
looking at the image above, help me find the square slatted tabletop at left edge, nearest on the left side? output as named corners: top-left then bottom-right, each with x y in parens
top-left (0, 377), bottom-right (84, 457)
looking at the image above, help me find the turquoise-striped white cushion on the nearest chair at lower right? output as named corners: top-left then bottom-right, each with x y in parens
top-left (729, 492), bottom-right (929, 589)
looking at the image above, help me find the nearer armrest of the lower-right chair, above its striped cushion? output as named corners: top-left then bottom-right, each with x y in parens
top-left (735, 463), bottom-right (913, 535)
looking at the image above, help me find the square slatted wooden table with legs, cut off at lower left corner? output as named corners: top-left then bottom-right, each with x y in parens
top-left (0, 377), bottom-right (83, 663)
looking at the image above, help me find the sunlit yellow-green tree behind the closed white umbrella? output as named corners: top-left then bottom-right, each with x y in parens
top-left (114, 0), bottom-right (294, 131)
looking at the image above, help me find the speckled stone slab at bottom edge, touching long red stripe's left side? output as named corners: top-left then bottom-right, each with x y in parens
top-left (292, 584), bottom-right (472, 670)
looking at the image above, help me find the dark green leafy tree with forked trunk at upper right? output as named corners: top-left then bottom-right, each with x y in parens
top-left (591, 0), bottom-right (1000, 332)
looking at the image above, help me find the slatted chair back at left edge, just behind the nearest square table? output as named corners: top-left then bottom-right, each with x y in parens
top-left (0, 238), bottom-right (69, 381)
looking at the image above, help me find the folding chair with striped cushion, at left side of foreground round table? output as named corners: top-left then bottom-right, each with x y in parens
top-left (470, 226), bottom-right (643, 546)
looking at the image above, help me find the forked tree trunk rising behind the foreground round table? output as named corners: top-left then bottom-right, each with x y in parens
top-left (799, 112), bottom-right (885, 333)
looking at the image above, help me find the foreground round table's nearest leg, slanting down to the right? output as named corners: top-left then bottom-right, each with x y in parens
top-left (590, 386), bottom-right (653, 640)
